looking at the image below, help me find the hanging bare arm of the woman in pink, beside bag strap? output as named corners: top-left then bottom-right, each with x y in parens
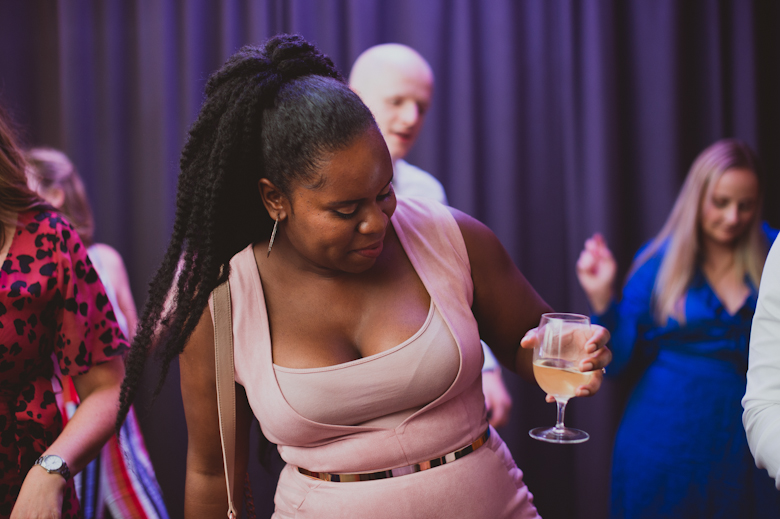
top-left (179, 307), bottom-right (252, 519)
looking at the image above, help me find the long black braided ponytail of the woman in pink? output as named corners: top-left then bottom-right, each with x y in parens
top-left (117, 35), bottom-right (376, 426)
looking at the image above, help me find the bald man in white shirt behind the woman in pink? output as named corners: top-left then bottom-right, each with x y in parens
top-left (349, 43), bottom-right (512, 427)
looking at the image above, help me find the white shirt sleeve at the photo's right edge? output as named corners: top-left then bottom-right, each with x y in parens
top-left (742, 239), bottom-right (780, 489)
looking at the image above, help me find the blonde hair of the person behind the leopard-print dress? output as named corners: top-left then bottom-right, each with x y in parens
top-left (26, 148), bottom-right (95, 247)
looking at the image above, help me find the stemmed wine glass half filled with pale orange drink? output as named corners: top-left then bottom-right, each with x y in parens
top-left (528, 314), bottom-right (593, 443)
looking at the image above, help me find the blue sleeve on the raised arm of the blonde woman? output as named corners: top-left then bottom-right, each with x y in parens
top-left (591, 246), bottom-right (661, 377)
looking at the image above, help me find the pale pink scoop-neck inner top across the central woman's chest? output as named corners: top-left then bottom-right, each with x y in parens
top-left (274, 300), bottom-right (460, 429)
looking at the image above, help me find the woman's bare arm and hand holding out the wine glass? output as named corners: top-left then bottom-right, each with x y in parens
top-left (450, 208), bottom-right (612, 396)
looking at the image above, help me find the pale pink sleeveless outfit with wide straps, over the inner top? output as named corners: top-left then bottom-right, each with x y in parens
top-left (216, 198), bottom-right (538, 519)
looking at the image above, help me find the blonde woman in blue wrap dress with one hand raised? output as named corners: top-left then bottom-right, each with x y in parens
top-left (577, 139), bottom-right (780, 519)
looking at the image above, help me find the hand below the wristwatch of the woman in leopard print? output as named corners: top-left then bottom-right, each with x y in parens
top-left (11, 466), bottom-right (66, 519)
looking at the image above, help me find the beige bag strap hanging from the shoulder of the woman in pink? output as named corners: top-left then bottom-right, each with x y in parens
top-left (213, 281), bottom-right (236, 519)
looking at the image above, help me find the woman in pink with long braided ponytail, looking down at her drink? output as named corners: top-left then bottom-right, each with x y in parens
top-left (120, 36), bottom-right (611, 518)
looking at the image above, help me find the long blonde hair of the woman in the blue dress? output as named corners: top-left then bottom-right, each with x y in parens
top-left (629, 139), bottom-right (769, 326)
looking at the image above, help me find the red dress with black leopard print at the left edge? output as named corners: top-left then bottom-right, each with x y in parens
top-left (0, 210), bottom-right (128, 518)
